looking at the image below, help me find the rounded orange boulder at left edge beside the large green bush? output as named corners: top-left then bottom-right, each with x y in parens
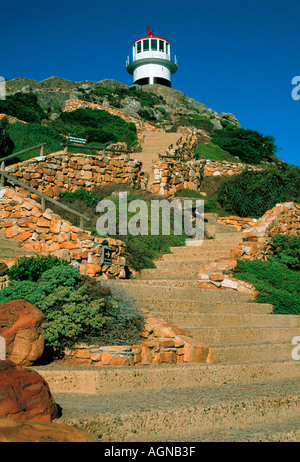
top-left (0, 299), bottom-right (45, 366)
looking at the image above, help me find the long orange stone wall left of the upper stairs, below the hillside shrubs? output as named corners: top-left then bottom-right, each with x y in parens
top-left (6, 151), bottom-right (147, 197)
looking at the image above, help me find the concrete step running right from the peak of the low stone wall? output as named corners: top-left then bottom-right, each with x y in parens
top-left (151, 310), bottom-right (300, 328)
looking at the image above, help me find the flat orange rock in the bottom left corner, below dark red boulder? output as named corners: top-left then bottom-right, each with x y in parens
top-left (0, 419), bottom-right (93, 443)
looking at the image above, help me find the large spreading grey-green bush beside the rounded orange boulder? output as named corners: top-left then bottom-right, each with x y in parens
top-left (0, 266), bottom-right (143, 354)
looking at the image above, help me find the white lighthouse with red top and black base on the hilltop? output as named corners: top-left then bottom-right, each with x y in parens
top-left (126, 27), bottom-right (178, 87)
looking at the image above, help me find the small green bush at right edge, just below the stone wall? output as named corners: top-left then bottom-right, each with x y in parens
top-left (270, 234), bottom-right (300, 271)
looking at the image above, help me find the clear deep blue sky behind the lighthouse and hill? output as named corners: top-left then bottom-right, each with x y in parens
top-left (0, 0), bottom-right (300, 166)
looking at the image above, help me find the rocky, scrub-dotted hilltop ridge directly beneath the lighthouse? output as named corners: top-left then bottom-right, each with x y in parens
top-left (6, 77), bottom-right (240, 128)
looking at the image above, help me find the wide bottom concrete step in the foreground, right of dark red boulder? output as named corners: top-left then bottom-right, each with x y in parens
top-left (54, 379), bottom-right (300, 442)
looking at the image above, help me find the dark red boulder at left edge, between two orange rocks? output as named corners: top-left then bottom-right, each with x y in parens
top-left (0, 360), bottom-right (59, 422)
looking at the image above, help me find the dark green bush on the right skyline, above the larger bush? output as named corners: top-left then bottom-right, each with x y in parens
top-left (212, 126), bottom-right (277, 164)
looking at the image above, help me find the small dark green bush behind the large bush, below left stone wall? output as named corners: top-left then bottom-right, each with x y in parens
top-left (7, 255), bottom-right (68, 282)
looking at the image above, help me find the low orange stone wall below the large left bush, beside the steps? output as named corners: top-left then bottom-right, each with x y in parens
top-left (62, 316), bottom-right (214, 366)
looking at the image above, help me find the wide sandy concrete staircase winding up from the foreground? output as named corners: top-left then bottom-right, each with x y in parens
top-left (35, 225), bottom-right (300, 442)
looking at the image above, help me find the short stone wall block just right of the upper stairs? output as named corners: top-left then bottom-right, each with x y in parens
top-left (152, 159), bottom-right (205, 197)
